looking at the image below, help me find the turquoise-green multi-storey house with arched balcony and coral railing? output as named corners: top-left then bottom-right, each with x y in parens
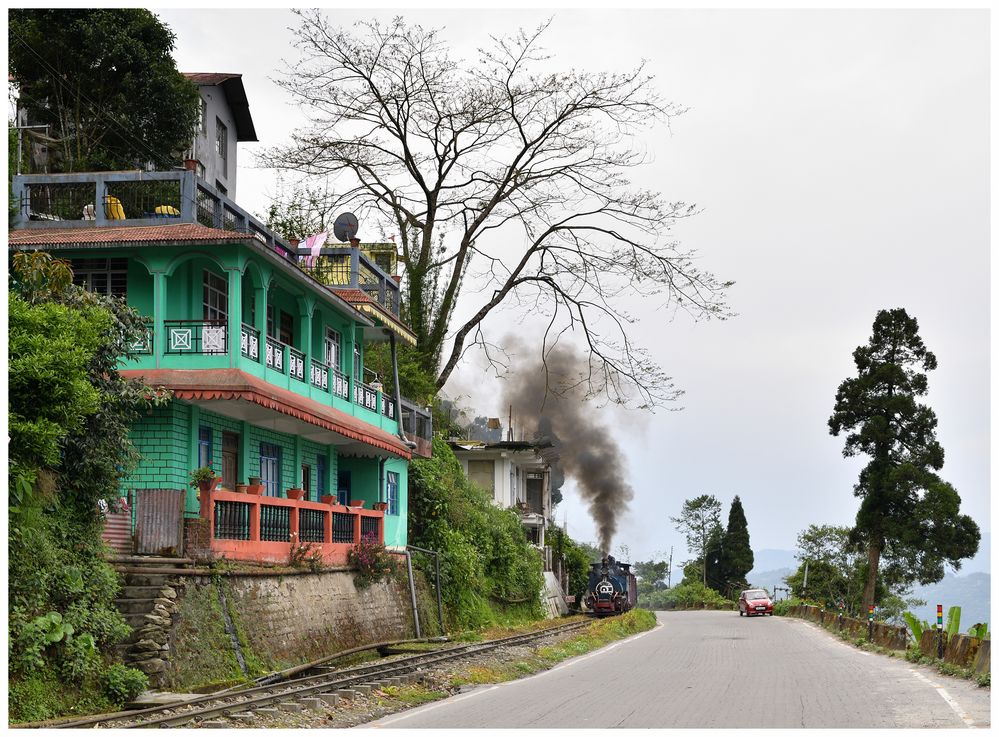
top-left (9, 171), bottom-right (430, 563)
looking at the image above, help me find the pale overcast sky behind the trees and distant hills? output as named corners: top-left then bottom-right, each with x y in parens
top-left (157, 10), bottom-right (991, 559)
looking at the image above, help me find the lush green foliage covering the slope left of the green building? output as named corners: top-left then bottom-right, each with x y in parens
top-left (8, 253), bottom-right (164, 720)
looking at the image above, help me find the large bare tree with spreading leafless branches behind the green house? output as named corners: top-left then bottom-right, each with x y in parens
top-left (263, 11), bottom-right (729, 406)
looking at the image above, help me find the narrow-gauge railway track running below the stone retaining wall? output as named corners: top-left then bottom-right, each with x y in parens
top-left (50, 621), bottom-right (591, 729)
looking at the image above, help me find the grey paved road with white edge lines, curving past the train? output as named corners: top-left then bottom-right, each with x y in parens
top-left (368, 612), bottom-right (990, 729)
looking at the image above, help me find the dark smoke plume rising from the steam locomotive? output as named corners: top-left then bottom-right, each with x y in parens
top-left (503, 341), bottom-right (634, 553)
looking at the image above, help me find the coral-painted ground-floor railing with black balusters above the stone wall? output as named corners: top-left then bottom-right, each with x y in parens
top-left (201, 490), bottom-right (385, 565)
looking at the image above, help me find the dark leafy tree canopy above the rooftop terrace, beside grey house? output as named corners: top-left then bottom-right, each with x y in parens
top-left (7, 8), bottom-right (199, 171)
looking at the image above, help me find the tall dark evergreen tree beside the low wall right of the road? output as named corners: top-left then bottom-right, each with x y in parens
top-left (829, 309), bottom-right (980, 607)
